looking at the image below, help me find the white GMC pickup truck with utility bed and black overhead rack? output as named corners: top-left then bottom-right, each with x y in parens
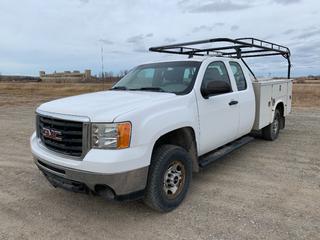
top-left (31, 38), bottom-right (292, 212)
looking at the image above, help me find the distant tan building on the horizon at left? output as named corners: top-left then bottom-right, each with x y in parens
top-left (39, 70), bottom-right (95, 83)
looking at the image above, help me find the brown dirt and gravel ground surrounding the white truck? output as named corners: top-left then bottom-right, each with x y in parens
top-left (0, 85), bottom-right (320, 240)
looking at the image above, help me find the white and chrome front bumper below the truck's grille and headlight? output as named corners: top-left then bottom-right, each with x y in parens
top-left (30, 134), bottom-right (151, 196)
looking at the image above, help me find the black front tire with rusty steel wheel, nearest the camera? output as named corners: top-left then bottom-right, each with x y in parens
top-left (144, 145), bottom-right (192, 212)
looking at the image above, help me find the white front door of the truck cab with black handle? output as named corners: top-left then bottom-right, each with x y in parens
top-left (196, 61), bottom-right (239, 155)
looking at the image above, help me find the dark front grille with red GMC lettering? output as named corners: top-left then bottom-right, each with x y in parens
top-left (37, 115), bottom-right (87, 157)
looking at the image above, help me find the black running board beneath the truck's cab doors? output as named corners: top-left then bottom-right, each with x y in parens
top-left (199, 136), bottom-right (254, 167)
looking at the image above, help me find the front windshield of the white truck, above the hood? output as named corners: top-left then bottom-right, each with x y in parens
top-left (112, 61), bottom-right (201, 94)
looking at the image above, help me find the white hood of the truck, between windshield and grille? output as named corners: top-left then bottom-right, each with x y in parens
top-left (37, 91), bottom-right (176, 122)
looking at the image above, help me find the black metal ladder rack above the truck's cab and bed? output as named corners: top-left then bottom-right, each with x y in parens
top-left (149, 38), bottom-right (291, 78)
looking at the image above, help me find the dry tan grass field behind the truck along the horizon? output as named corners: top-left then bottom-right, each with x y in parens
top-left (0, 82), bottom-right (320, 107)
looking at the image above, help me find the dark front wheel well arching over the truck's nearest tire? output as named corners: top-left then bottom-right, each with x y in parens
top-left (153, 127), bottom-right (199, 172)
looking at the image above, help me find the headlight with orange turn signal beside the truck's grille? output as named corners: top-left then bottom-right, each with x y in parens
top-left (92, 122), bottom-right (131, 149)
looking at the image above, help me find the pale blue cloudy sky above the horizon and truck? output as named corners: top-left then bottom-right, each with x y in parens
top-left (0, 0), bottom-right (320, 76)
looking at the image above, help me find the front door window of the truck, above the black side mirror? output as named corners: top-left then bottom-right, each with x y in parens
top-left (202, 62), bottom-right (231, 87)
